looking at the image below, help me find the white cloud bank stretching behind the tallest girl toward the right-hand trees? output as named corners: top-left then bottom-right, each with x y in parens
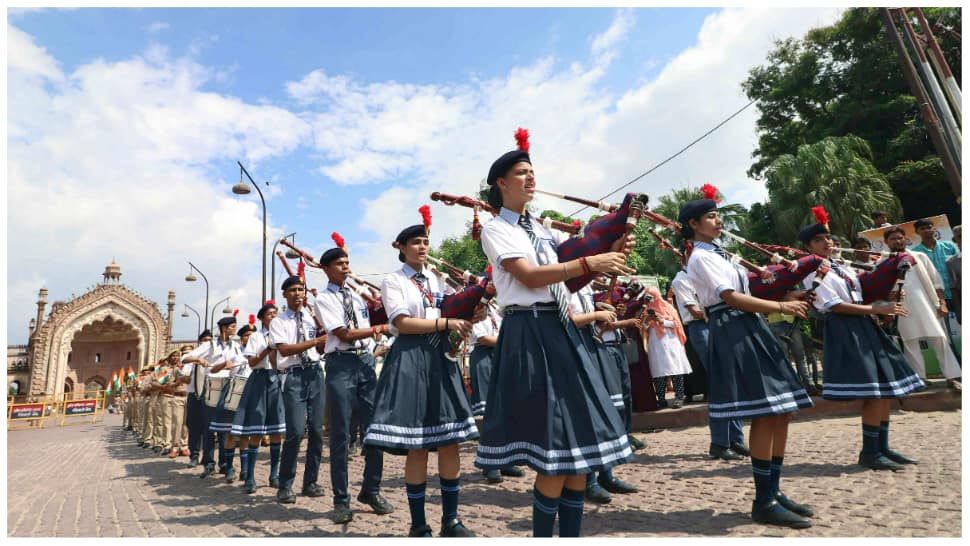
top-left (287, 9), bottom-right (840, 280)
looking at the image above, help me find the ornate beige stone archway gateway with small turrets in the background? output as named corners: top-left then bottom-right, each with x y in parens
top-left (22, 262), bottom-right (174, 397)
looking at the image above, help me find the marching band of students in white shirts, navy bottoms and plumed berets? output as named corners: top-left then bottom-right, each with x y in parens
top-left (123, 131), bottom-right (923, 537)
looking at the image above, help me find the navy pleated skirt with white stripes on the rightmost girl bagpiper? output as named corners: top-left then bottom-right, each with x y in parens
top-left (822, 313), bottom-right (926, 400)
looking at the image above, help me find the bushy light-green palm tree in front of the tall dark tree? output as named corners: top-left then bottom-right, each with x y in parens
top-left (765, 135), bottom-right (902, 241)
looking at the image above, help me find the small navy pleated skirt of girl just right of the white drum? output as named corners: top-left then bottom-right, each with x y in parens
top-left (229, 369), bottom-right (286, 436)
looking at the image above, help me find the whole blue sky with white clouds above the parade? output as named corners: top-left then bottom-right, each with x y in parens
top-left (7, 8), bottom-right (838, 342)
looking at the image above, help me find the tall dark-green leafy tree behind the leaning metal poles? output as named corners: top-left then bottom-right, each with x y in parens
top-left (742, 7), bottom-right (962, 223)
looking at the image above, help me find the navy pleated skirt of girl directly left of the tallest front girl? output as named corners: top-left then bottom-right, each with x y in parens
top-left (364, 334), bottom-right (478, 455)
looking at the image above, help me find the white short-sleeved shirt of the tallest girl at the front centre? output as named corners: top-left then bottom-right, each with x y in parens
top-left (482, 207), bottom-right (569, 307)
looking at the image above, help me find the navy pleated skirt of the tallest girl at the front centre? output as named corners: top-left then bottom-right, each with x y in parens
top-left (475, 306), bottom-right (633, 475)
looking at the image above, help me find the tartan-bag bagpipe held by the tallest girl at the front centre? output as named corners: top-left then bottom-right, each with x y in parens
top-left (431, 190), bottom-right (647, 292)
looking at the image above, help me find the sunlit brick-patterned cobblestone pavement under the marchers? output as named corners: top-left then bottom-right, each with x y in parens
top-left (7, 410), bottom-right (961, 537)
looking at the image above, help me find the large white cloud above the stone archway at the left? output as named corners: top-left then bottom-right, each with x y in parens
top-left (7, 26), bottom-right (310, 342)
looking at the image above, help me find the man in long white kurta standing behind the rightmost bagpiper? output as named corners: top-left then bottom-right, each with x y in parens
top-left (886, 230), bottom-right (963, 379)
